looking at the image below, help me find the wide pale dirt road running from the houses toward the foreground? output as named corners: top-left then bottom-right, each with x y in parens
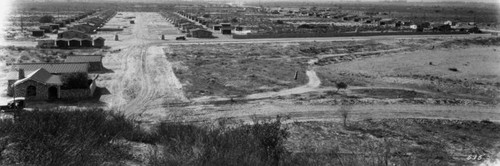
top-left (99, 13), bottom-right (187, 119)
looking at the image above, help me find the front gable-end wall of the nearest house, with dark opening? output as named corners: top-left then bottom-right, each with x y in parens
top-left (13, 80), bottom-right (50, 100)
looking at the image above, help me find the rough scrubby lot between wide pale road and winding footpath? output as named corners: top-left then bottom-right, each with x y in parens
top-left (167, 41), bottom-right (393, 98)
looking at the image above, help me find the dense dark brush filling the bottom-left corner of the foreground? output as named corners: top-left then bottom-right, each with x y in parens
top-left (0, 109), bottom-right (137, 165)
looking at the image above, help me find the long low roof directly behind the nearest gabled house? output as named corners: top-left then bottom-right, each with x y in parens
top-left (12, 62), bottom-right (89, 74)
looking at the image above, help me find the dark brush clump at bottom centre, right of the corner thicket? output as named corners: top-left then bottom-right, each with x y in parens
top-left (149, 118), bottom-right (288, 165)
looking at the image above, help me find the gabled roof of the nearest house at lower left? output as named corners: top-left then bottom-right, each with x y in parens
top-left (14, 68), bottom-right (62, 86)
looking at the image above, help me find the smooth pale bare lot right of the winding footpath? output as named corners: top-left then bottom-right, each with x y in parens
top-left (317, 41), bottom-right (500, 104)
